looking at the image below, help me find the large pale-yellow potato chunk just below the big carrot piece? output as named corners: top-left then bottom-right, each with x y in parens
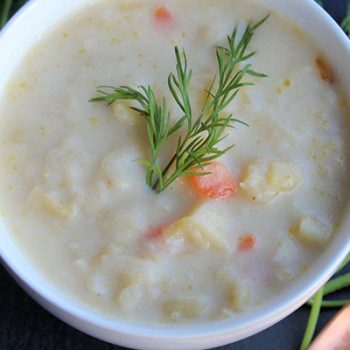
top-left (164, 205), bottom-right (230, 251)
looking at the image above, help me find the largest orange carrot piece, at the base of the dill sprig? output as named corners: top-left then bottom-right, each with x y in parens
top-left (188, 162), bottom-right (238, 199)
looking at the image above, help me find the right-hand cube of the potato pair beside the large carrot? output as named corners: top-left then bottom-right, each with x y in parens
top-left (267, 162), bottom-right (303, 192)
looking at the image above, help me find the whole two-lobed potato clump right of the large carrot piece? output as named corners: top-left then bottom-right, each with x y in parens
top-left (240, 160), bottom-right (303, 203)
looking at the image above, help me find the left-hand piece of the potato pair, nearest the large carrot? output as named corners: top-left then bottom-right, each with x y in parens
top-left (240, 161), bottom-right (279, 203)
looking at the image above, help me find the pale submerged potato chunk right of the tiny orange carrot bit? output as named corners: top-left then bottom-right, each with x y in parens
top-left (273, 237), bottom-right (301, 280)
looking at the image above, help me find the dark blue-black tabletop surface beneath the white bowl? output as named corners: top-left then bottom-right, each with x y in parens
top-left (0, 0), bottom-right (350, 350)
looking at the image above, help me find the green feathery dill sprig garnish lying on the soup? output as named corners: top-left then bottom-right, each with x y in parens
top-left (90, 16), bottom-right (268, 192)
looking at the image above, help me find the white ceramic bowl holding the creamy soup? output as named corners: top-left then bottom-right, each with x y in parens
top-left (0, 0), bottom-right (350, 350)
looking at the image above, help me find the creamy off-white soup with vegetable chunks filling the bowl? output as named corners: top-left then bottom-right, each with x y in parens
top-left (0, 0), bottom-right (349, 323)
